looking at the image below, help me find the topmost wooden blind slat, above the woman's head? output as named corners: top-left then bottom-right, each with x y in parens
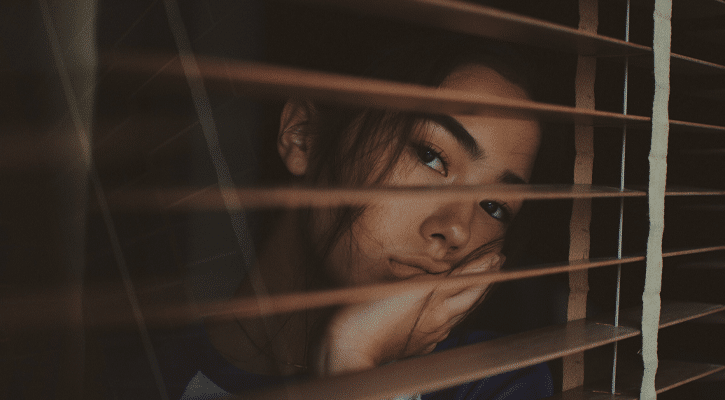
top-left (296, 0), bottom-right (651, 56)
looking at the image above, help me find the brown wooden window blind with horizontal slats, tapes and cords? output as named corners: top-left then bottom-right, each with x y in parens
top-left (0, 0), bottom-right (725, 399)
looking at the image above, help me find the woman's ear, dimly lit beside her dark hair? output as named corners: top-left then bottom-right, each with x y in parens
top-left (277, 100), bottom-right (312, 176)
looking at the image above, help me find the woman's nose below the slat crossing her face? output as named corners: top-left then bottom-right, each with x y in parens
top-left (420, 203), bottom-right (478, 259)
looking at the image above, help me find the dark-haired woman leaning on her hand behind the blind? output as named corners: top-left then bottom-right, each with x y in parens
top-left (172, 26), bottom-right (551, 398)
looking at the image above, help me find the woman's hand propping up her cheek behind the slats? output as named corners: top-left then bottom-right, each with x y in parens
top-left (315, 254), bottom-right (505, 375)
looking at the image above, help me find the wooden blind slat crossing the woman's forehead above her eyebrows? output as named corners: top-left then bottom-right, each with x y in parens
top-left (109, 53), bottom-right (650, 126)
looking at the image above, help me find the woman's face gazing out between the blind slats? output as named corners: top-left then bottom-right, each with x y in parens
top-left (304, 65), bottom-right (540, 286)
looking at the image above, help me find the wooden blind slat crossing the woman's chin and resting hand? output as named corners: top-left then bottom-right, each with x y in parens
top-left (8, 246), bottom-right (725, 330)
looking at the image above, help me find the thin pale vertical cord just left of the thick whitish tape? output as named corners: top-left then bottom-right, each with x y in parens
top-left (612, 0), bottom-right (630, 395)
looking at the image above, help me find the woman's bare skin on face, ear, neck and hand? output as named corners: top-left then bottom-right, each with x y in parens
top-left (207, 65), bottom-right (540, 376)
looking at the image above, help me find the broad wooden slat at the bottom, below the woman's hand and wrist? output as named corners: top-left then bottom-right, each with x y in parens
top-left (238, 320), bottom-right (639, 400)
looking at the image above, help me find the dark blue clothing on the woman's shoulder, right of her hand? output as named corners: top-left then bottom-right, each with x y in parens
top-left (422, 331), bottom-right (554, 400)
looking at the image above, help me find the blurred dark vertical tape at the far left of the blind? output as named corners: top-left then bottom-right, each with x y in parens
top-left (38, 0), bottom-right (97, 395)
